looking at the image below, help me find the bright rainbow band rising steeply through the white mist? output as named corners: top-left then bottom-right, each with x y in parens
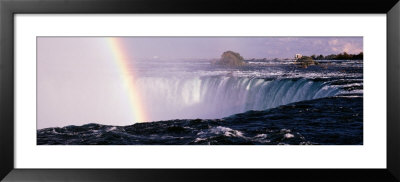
top-left (107, 37), bottom-right (149, 122)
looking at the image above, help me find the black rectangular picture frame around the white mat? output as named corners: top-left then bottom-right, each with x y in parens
top-left (0, 0), bottom-right (400, 182)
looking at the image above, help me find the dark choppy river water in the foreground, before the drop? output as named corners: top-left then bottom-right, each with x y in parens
top-left (37, 96), bottom-right (363, 145)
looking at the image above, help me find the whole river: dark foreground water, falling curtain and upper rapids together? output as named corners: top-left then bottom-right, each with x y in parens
top-left (37, 60), bottom-right (363, 145)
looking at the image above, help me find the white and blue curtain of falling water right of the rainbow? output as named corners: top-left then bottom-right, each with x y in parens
top-left (136, 76), bottom-right (339, 121)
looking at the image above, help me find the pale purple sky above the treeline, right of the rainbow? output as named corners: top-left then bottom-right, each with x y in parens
top-left (119, 37), bottom-right (363, 59)
